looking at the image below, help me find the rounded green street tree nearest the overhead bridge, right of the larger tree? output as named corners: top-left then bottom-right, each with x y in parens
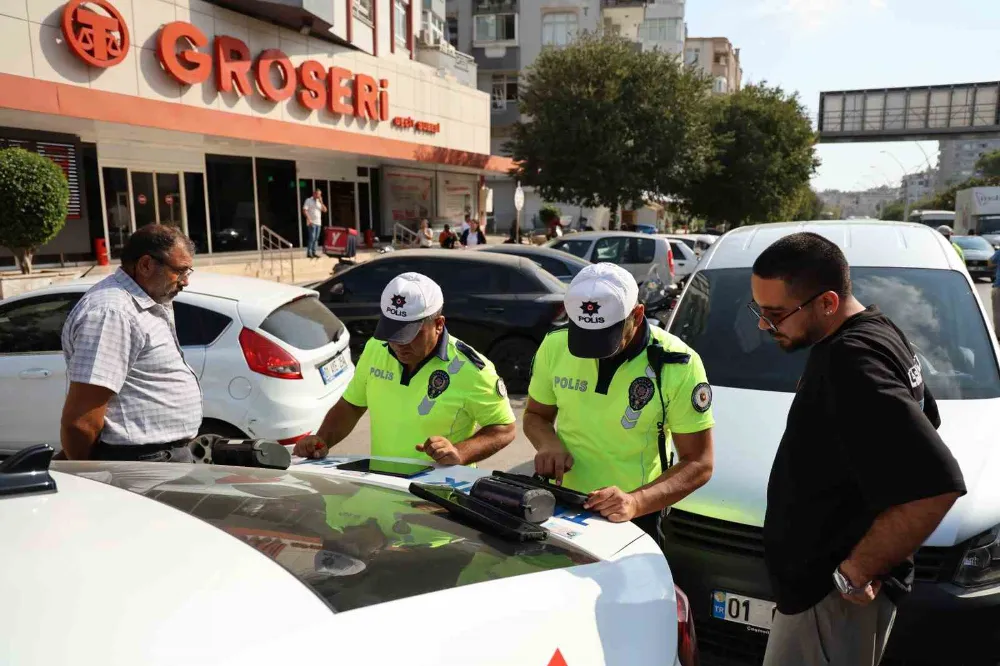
top-left (684, 83), bottom-right (819, 226)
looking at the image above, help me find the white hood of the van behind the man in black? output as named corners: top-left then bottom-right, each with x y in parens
top-left (677, 386), bottom-right (1000, 546)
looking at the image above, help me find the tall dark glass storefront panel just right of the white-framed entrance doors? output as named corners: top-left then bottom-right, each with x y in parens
top-left (205, 155), bottom-right (258, 252)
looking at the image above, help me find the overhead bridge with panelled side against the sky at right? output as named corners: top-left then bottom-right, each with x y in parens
top-left (817, 81), bottom-right (1000, 143)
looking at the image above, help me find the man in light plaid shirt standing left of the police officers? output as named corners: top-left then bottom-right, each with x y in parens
top-left (61, 224), bottom-right (202, 462)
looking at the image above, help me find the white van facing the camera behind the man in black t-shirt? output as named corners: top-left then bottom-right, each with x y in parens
top-left (663, 221), bottom-right (1000, 666)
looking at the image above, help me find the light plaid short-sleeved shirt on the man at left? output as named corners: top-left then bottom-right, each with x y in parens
top-left (62, 268), bottom-right (202, 444)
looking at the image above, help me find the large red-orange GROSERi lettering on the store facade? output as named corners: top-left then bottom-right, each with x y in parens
top-left (156, 21), bottom-right (389, 120)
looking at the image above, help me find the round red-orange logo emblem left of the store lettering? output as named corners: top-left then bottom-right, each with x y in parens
top-left (62, 0), bottom-right (129, 68)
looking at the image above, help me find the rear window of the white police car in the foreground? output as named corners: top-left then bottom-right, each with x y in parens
top-left (53, 462), bottom-right (597, 612)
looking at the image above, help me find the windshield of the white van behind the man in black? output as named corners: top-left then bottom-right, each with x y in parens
top-left (670, 267), bottom-right (1000, 400)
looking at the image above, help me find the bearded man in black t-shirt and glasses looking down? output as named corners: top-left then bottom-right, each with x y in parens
top-left (750, 233), bottom-right (965, 666)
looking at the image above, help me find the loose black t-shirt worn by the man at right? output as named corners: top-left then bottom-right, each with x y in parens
top-left (764, 306), bottom-right (965, 615)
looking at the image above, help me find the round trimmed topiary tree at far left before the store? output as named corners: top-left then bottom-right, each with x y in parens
top-left (0, 148), bottom-right (69, 274)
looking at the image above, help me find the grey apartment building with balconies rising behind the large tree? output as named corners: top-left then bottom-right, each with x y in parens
top-left (454, 0), bottom-right (686, 231)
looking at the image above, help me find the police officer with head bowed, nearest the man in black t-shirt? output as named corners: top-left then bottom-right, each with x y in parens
top-left (524, 263), bottom-right (714, 538)
